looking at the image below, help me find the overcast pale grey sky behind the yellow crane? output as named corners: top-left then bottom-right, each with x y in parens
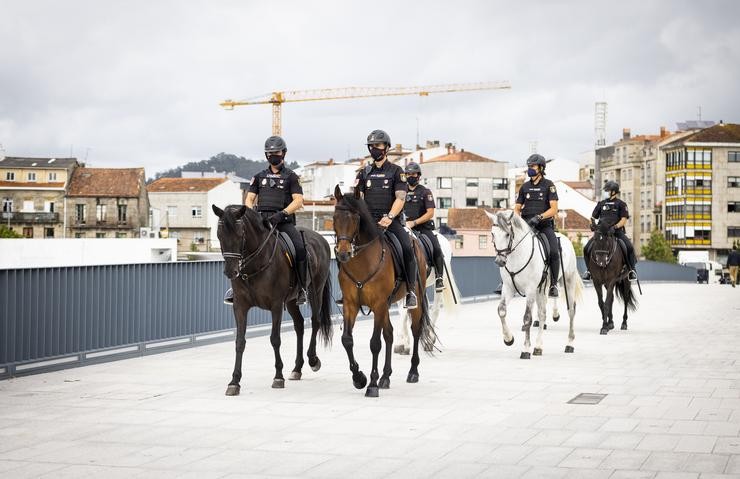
top-left (0, 0), bottom-right (740, 176)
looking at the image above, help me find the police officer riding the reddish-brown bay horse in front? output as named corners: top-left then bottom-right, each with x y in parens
top-left (355, 130), bottom-right (418, 309)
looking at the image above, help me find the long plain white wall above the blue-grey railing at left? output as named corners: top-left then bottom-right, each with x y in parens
top-left (0, 238), bottom-right (177, 269)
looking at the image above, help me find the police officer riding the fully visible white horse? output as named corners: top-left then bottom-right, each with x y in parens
top-left (514, 154), bottom-right (560, 298)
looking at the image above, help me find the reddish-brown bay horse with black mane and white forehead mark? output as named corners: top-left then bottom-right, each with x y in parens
top-left (334, 186), bottom-right (434, 397)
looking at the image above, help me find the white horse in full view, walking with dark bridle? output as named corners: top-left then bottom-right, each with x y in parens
top-left (486, 210), bottom-right (583, 359)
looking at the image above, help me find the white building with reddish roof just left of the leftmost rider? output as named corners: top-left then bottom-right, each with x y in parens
top-left (147, 178), bottom-right (242, 251)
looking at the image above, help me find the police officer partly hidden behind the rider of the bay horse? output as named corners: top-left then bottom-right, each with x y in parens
top-left (403, 161), bottom-right (445, 292)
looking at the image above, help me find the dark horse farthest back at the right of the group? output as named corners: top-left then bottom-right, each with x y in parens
top-left (586, 223), bottom-right (637, 334)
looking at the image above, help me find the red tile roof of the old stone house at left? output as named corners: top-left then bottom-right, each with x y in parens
top-left (67, 167), bottom-right (144, 198)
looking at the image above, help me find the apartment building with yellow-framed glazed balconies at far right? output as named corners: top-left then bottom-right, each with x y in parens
top-left (660, 122), bottom-right (740, 259)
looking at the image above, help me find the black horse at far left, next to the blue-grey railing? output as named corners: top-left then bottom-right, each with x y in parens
top-left (213, 205), bottom-right (332, 396)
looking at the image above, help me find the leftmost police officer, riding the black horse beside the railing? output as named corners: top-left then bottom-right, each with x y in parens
top-left (224, 136), bottom-right (307, 304)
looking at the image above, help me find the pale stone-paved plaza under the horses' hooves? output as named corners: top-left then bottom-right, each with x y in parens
top-left (0, 284), bottom-right (740, 479)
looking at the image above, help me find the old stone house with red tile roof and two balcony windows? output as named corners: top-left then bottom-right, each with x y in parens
top-left (67, 167), bottom-right (149, 238)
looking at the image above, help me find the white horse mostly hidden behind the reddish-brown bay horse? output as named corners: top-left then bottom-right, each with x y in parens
top-left (393, 231), bottom-right (460, 354)
